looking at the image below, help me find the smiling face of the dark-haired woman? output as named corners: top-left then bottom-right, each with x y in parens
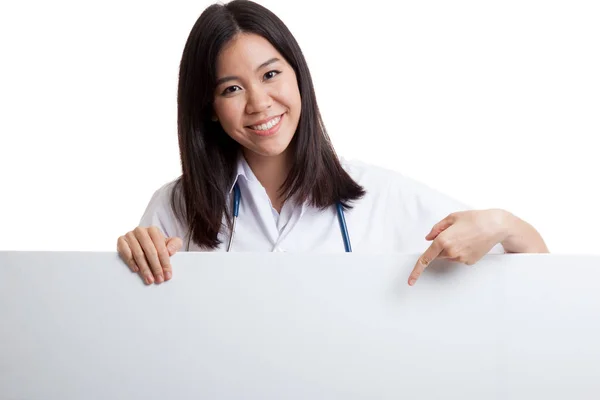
top-left (213, 33), bottom-right (301, 164)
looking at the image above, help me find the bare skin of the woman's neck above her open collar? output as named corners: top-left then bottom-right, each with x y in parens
top-left (244, 151), bottom-right (291, 212)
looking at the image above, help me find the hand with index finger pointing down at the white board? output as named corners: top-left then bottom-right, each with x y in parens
top-left (408, 209), bottom-right (511, 286)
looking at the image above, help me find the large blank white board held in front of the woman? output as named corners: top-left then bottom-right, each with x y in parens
top-left (0, 252), bottom-right (600, 400)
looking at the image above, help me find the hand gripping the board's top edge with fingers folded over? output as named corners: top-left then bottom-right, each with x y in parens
top-left (117, 226), bottom-right (183, 285)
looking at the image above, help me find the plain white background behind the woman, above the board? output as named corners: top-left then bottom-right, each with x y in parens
top-left (0, 0), bottom-right (600, 254)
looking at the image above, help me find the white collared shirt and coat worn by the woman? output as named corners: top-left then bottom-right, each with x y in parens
top-left (140, 157), bottom-right (504, 253)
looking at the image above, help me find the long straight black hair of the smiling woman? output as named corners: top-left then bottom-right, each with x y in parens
top-left (171, 0), bottom-right (365, 249)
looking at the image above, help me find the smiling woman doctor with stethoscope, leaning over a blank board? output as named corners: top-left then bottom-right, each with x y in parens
top-left (117, 0), bottom-right (548, 285)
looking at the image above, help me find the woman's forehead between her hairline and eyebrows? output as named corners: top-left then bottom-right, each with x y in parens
top-left (217, 33), bottom-right (284, 76)
